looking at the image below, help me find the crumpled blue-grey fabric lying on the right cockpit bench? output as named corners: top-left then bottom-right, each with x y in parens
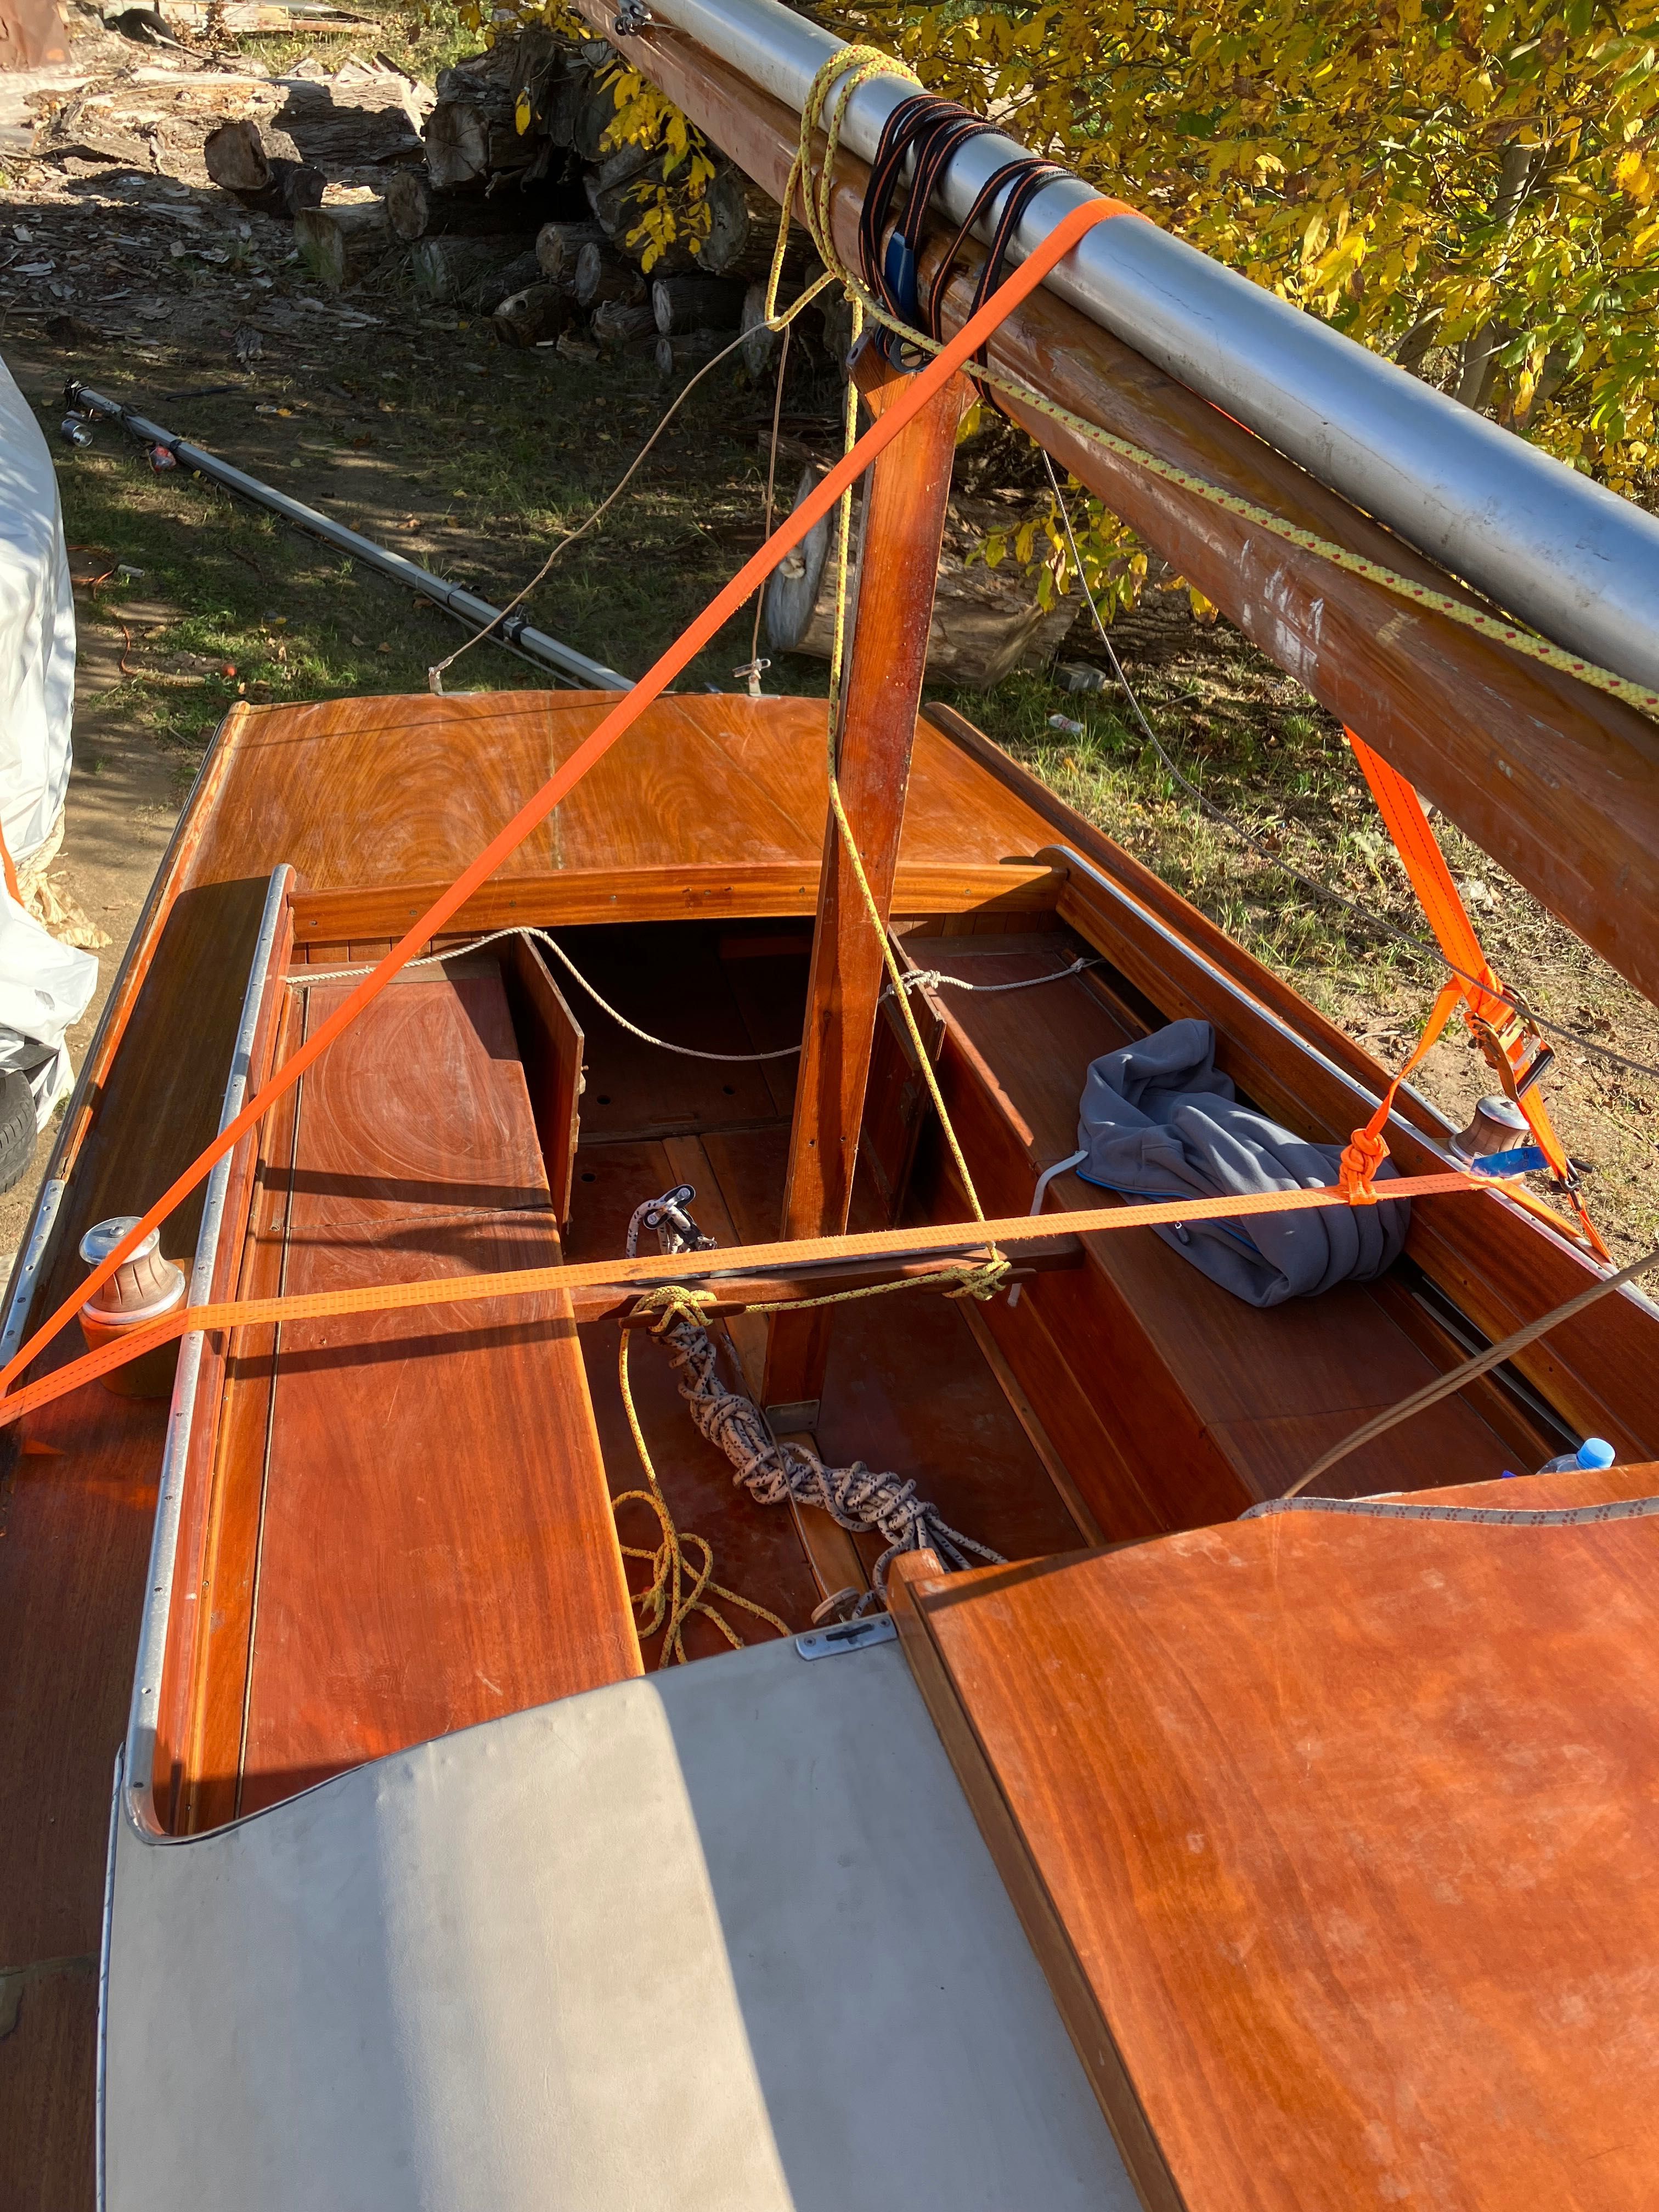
top-left (1077, 1022), bottom-right (1411, 1305)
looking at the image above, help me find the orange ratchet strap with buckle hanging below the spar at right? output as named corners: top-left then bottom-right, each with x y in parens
top-left (1342, 730), bottom-right (1608, 1259)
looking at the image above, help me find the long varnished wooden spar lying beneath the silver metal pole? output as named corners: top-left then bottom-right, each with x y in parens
top-left (577, 0), bottom-right (1659, 997)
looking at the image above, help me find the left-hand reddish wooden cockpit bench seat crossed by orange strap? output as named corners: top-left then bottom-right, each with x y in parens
top-left (186, 962), bottom-right (639, 1825)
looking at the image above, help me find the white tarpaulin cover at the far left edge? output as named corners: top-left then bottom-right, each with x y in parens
top-left (0, 360), bottom-right (97, 1126)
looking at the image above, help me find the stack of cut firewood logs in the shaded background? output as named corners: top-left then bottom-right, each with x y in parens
top-left (204, 29), bottom-right (845, 376)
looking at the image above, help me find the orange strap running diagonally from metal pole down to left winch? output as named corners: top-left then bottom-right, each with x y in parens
top-left (0, 201), bottom-right (1119, 1391)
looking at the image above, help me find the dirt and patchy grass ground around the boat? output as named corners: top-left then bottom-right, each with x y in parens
top-left (0, 4), bottom-right (1659, 1259)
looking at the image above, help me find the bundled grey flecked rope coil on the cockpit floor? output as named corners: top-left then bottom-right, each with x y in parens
top-left (628, 1199), bottom-right (1005, 1619)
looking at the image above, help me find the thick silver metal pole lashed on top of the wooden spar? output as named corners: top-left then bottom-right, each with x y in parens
top-left (604, 0), bottom-right (1659, 686)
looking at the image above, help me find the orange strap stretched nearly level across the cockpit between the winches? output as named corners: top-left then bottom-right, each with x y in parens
top-left (0, 1172), bottom-right (1477, 1429)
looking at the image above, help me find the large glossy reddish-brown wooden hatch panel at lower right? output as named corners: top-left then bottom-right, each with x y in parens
top-left (900, 1466), bottom-right (1659, 2212)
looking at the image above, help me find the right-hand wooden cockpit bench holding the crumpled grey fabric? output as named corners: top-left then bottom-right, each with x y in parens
top-left (907, 936), bottom-right (1544, 1537)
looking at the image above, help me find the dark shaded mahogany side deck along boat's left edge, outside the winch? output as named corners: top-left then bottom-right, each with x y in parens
top-left (0, 881), bottom-right (266, 2212)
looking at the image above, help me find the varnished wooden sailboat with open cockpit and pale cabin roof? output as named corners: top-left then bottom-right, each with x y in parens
top-left (0, 11), bottom-right (1659, 2212)
